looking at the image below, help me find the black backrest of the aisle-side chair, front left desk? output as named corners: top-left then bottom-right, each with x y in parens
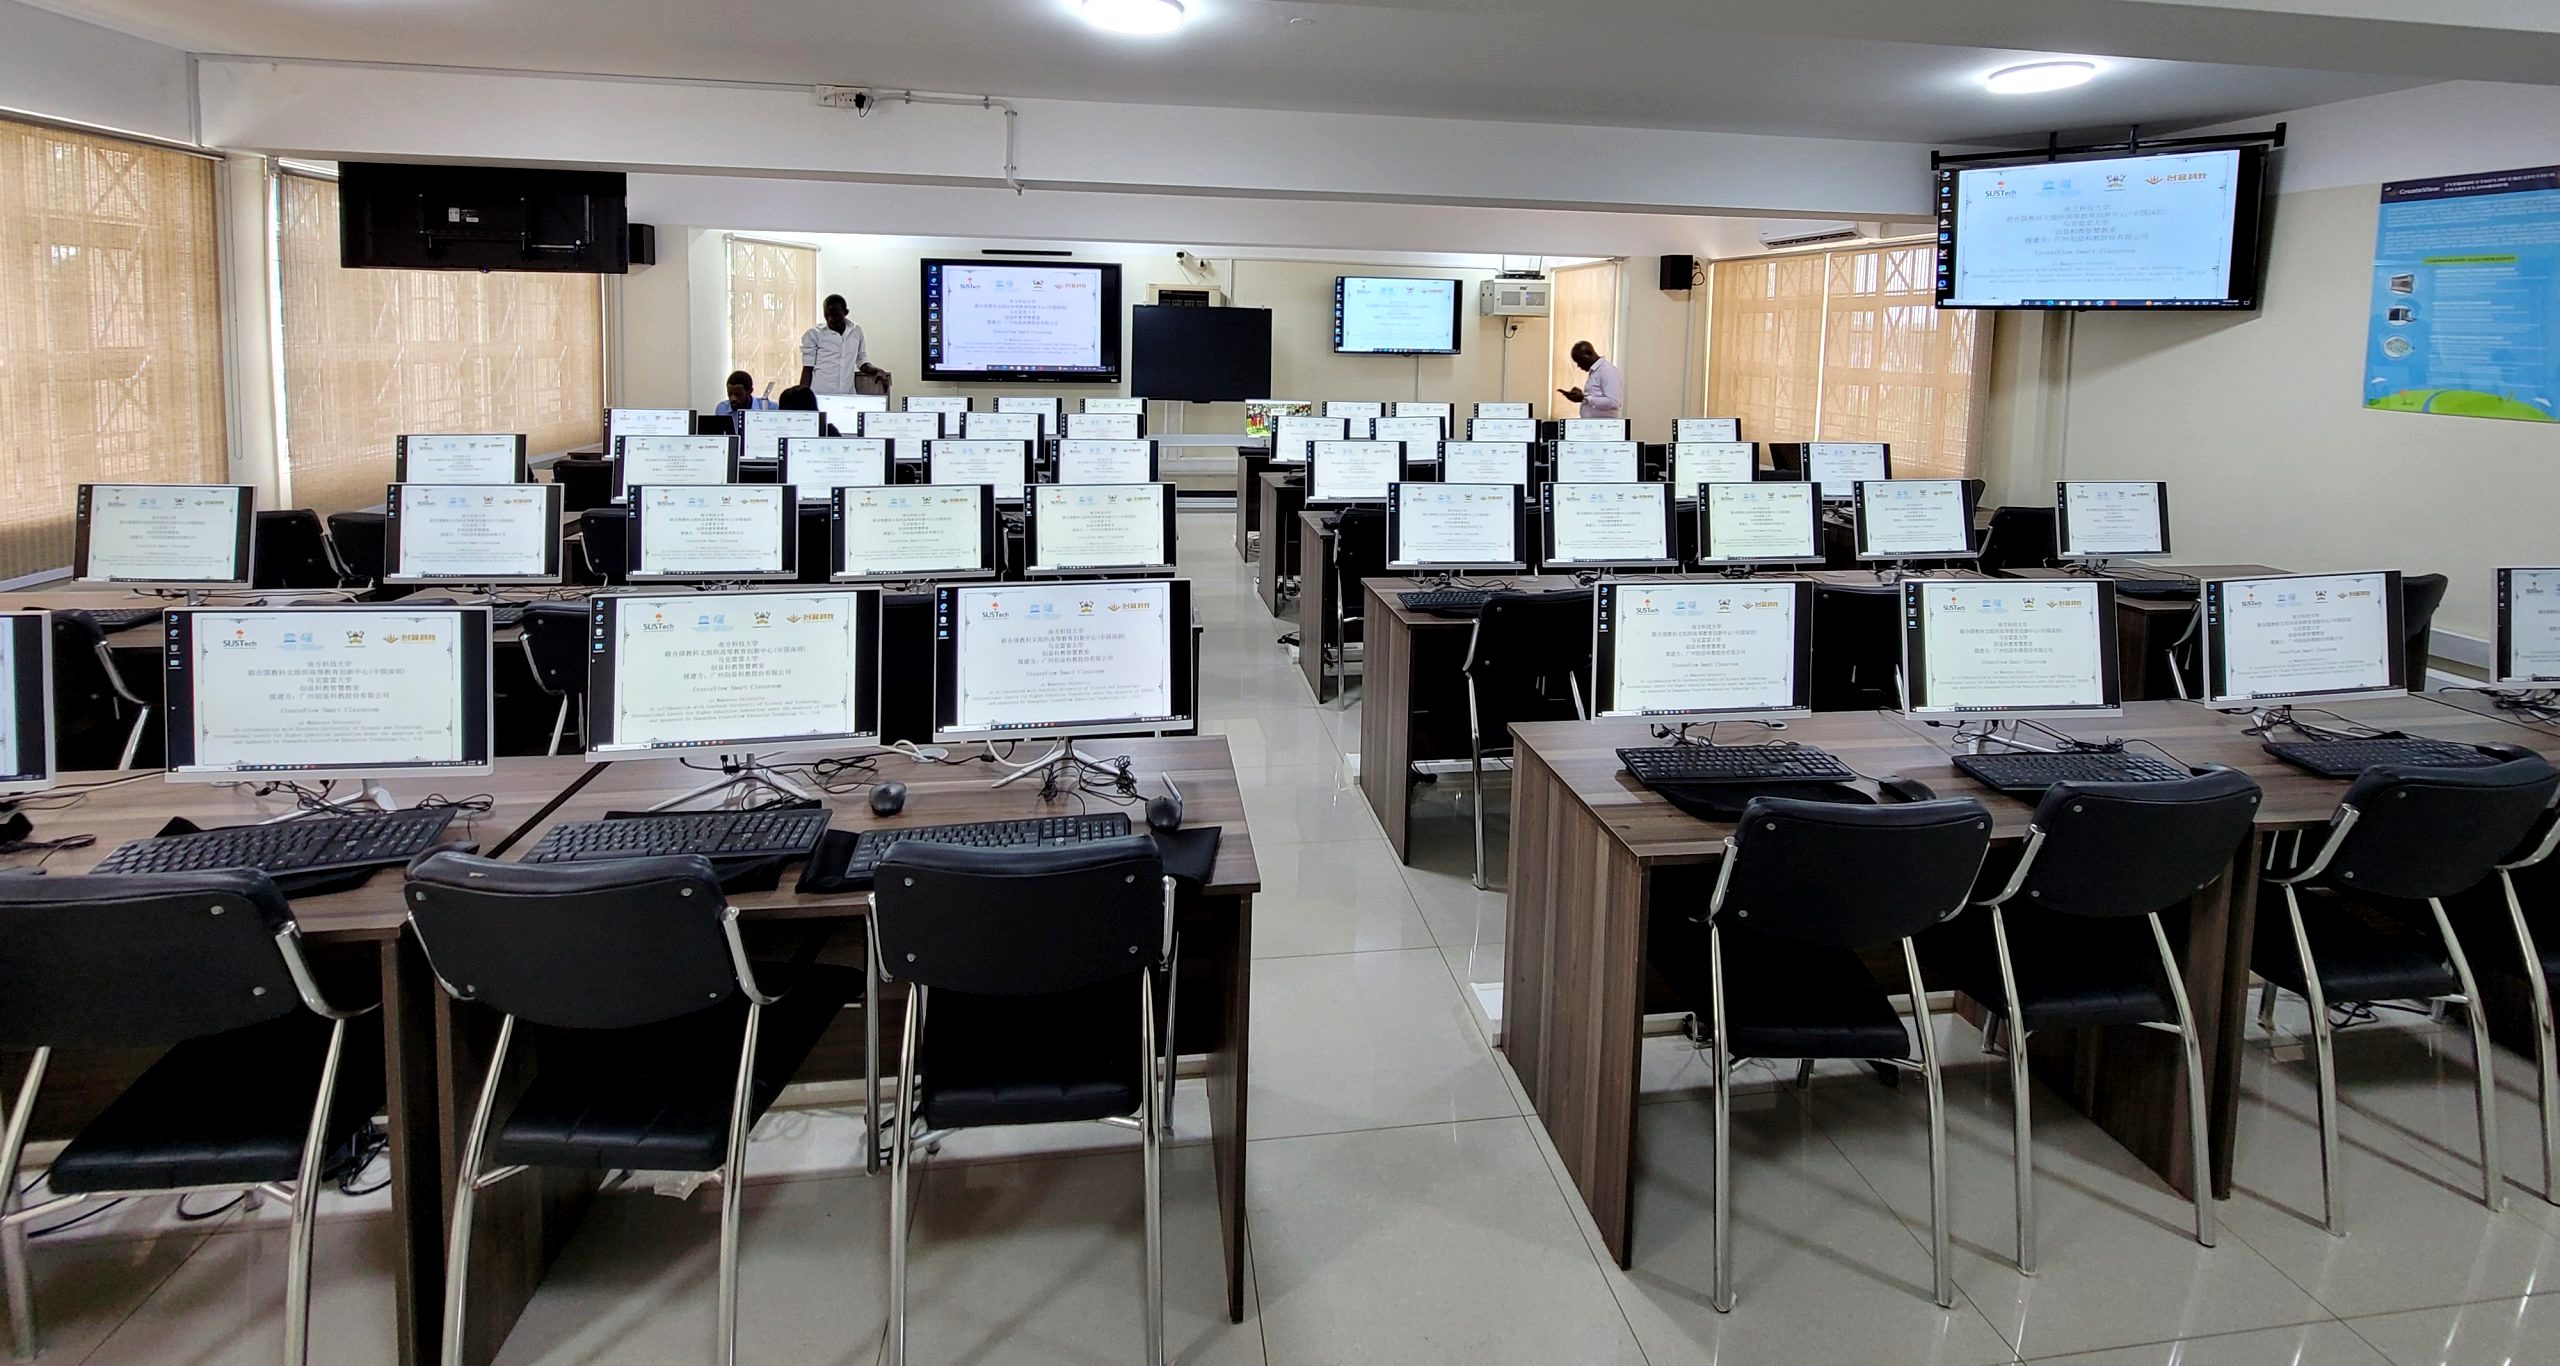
top-left (870, 834), bottom-right (1165, 997)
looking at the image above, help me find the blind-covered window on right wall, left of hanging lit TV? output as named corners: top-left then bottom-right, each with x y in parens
top-left (1708, 243), bottom-right (1989, 478)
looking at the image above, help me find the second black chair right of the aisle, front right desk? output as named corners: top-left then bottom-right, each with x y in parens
top-left (1920, 767), bottom-right (2258, 1271)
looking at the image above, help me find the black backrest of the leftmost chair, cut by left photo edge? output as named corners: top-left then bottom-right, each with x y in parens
top-left (0, 870), bottom-right (302, 1049)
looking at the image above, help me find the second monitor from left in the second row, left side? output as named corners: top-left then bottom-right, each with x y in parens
top-left (381, 483), bottom-right (563, 583)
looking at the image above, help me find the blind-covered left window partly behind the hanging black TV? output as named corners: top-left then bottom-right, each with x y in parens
top-left (276, 177), bottom-right (604, 517)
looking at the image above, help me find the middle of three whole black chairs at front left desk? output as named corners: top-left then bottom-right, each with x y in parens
top-left (407, 852), bottom-right (860, 1366)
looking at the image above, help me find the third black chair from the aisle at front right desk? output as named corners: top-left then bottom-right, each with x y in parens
top-left (2250, 760), bottom-right (2560, 1233)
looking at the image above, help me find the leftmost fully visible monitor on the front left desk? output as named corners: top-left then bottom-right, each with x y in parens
top-left (161, 604), bottom-right (492, 783)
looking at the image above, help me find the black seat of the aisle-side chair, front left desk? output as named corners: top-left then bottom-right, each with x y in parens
top-left (916, 977), bottom-right (1147, 1128)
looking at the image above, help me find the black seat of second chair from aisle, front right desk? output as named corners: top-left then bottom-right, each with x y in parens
top-left (1920, 906), bottom-right (2179, 1031)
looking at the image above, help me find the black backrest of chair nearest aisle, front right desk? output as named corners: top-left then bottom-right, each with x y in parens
top-left (1718, 798), bottom-right (1992, 949)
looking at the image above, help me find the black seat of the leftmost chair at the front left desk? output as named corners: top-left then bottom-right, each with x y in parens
top-left (46, 1010), bottom-right (381, 1195)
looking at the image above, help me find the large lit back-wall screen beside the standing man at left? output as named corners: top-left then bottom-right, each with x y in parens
top-left (919, 258), bottom-right (1121, 384)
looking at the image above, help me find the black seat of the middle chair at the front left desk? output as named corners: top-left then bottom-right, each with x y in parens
top-left (489, 964), bottom-right (863, 1172)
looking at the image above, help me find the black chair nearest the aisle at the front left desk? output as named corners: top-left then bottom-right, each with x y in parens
top-left (870, 836), bottom-right (1175, 1366)
